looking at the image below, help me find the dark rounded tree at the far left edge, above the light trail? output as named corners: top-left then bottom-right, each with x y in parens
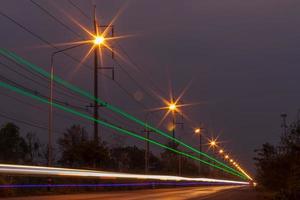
top-left (0, 123), bottom-right (28, 163)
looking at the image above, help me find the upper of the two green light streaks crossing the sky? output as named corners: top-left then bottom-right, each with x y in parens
top-left (0, 48), bottom-right (244, 180)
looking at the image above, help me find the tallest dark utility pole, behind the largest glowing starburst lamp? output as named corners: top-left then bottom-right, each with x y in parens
top-left (94, 5), bottom-right (99, 144)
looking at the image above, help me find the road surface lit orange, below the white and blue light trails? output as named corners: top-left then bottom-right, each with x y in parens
top-left (0, 186), bottom-right (258, 200)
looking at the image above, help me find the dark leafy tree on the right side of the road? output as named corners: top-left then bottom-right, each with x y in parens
top-left (254, 119), bottom-right (300, 200)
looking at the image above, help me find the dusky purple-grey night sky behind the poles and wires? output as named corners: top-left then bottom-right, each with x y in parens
top-left (0, 0), bottom-right (300, 175)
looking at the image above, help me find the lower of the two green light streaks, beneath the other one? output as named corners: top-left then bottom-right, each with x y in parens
top-left (0, 82), bottom-right (247, 180)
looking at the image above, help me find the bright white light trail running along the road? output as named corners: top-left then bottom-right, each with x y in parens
top-left (0, 164), bottom-right (249, 185)
